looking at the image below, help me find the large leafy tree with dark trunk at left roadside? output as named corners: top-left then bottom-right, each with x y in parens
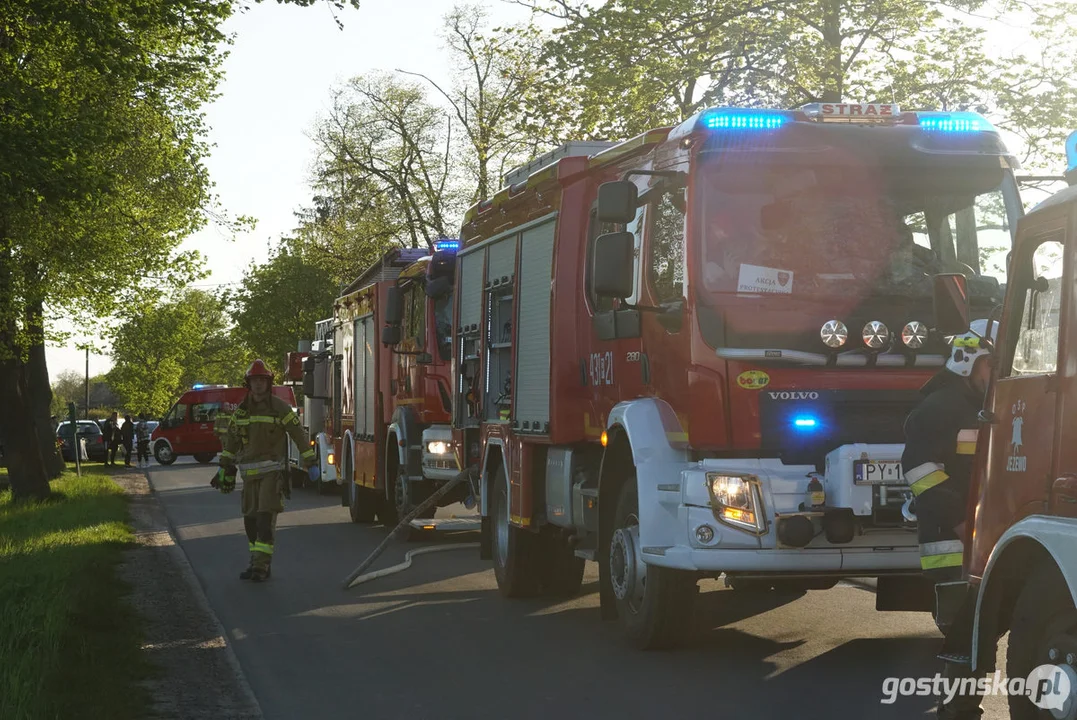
top-left (0, 0), bottom-right (358, 499)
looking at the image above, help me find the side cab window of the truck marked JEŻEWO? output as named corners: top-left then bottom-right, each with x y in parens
top-left (1010, 240), bottom-right (1064, 377)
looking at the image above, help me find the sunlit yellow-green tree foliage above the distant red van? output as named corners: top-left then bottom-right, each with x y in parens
top-left (108, 290), bottom-right (250, 414)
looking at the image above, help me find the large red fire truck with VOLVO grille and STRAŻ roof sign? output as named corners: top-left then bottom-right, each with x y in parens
top-left (452, 103), bottom-right (1022, 648)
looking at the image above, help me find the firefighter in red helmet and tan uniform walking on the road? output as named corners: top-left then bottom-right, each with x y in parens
top-left (214, 359), bottom-right (320, 582)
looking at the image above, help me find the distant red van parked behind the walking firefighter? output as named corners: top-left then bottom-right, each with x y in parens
top-left (150, 385), bottom-right (295, 465)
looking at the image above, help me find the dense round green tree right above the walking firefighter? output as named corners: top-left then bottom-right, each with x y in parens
top-left (229, 242), bottom-right (337, 373)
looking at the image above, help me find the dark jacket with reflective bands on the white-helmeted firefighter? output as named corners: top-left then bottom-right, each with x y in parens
top-left (901, 372), bottom-right (983, 579)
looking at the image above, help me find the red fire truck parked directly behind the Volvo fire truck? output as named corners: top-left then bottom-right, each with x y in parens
top-left (305, 240), bottom-right (470, 527)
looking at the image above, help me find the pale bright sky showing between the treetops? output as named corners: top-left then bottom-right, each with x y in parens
top-left (46, 0), bottom-right (1061, 378)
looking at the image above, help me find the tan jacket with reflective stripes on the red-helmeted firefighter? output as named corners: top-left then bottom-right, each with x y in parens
top-left (219, 394), bottom-right (314, 478)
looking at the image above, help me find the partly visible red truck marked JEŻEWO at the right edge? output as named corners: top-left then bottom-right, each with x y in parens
top-left (936, 132), bottom-right (1077, 720)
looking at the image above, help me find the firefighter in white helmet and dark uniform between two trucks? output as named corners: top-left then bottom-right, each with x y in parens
top-left (901, 320), bottom-right (998, 720)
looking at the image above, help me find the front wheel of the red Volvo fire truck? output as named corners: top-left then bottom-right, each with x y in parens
top-left (607, 472), bottom-right (698, 650)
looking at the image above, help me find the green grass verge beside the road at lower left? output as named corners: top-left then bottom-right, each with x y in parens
top-left (0, 465), bottom-right (150, 720)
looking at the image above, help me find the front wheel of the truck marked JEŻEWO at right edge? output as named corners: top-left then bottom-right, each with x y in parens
top-left (1006, 562), bottom-right (1077, 720)
